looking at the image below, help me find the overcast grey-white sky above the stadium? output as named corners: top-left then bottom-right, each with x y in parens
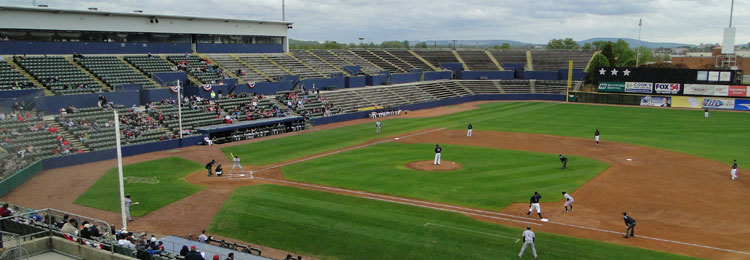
top-left (0, 0), bottom-right (750, 44)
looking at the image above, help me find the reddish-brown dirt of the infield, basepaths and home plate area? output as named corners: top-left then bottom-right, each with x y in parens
top-left (3, 100), bottom-right (750, 259)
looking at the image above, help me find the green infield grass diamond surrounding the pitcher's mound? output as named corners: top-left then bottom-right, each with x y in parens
top-left (282, 143), bottom-right (608, 210)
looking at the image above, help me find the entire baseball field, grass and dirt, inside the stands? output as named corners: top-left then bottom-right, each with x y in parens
top-left (4, 102), bottom-right (750, 259)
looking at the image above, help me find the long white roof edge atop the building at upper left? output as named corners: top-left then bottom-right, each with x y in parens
top-left (0, 5), bottom-right (294, 25)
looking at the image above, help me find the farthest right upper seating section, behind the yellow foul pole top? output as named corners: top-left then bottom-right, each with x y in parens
top-left (531, 50), bottom-right (594, 71)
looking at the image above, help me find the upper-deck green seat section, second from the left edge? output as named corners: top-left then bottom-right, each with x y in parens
top-left (18, 56), bottom-right (102, 95)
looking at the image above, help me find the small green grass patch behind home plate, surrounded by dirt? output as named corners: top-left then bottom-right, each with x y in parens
top-left (74, 157), bottom-right (203, 216)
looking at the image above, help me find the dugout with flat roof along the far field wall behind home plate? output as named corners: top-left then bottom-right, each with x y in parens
top-left (200, 116), bottom-right (305, 143)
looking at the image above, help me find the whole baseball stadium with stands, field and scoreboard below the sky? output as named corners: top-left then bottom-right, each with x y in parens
top-left (0, 2), bottom-right (750, 260)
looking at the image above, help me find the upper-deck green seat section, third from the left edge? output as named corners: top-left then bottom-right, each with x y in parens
top-left (78, 56), bottom-right (157, 89)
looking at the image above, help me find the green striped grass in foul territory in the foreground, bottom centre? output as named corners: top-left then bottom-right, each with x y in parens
top-left (208, 185), bottom-right (704, 260)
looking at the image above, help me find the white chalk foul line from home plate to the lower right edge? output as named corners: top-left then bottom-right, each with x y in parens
top-left (256, 177), bottom-right (750, 255)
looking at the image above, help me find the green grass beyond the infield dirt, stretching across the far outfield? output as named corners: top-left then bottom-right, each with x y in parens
top-left (222, 102), bottom-right (750, 165)
